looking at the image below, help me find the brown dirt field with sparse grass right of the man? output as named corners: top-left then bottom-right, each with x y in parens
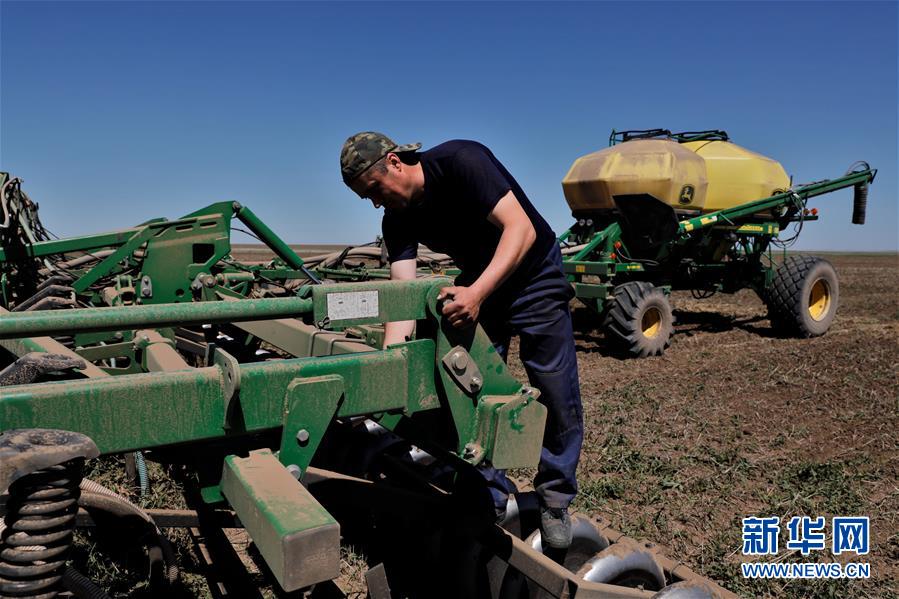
top-left (510, 255), bottom-right (899, 598)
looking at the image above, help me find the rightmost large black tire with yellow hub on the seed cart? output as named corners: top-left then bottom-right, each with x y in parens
top-left (765, 256), bottom-right (840, 337)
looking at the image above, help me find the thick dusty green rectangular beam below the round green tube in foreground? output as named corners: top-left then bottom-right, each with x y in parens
top-left (0, 339), bottom-right (440, 453)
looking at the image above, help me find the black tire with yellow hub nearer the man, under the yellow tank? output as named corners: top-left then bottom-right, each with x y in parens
top-left (604, 281), bottom-right (674, 358)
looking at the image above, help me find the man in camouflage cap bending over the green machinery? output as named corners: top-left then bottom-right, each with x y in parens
top-left (340, 131), bottom-right (583, 548)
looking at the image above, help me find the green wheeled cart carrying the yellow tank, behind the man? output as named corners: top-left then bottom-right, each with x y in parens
top-left (559, 129), bottom-right (877, 357)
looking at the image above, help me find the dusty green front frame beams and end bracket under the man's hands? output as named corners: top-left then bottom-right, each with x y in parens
top-left (0, 279), bottom-right (546, 590)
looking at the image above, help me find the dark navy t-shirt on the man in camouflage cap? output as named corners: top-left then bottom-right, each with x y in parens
top-left (381, 140), bottom-right (556, 310)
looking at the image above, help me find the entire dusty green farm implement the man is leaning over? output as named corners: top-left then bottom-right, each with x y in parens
top-left (0, 173), bottom-right (728, 599)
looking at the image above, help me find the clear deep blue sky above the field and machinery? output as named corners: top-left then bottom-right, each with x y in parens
top-left (0, 0), bottom-right (899, 250)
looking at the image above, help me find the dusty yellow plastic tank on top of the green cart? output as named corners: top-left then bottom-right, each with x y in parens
top-left (562, 139), bottom-right (790, 214)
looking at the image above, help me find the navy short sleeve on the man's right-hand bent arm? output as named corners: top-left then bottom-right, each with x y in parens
top-left (452, 143), bottom-right (512, 218)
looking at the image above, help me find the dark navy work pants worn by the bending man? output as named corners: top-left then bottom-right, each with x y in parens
top-left (480, 246), bottom-right (584, 509)
